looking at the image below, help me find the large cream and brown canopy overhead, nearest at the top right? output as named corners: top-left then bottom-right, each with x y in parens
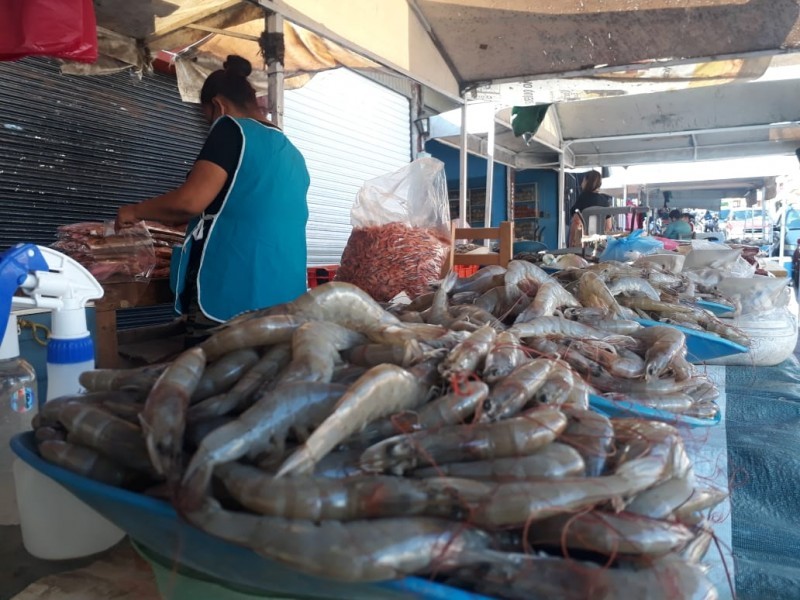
top-left (259, 0), bottom-right (800, 98)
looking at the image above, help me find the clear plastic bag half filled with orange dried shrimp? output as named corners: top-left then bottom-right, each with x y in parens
top-left (336, 158), bottom-right (450, 302)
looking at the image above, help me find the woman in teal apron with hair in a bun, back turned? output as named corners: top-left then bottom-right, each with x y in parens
top-left (117, 56), bottom-right (309, 341)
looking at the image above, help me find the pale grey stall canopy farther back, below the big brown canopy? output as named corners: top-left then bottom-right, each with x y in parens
top-left (430, 54), bottom-right (800, 169)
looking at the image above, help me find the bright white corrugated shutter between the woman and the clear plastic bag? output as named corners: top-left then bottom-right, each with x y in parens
top-left (284, 69), bottom-right (411, 265)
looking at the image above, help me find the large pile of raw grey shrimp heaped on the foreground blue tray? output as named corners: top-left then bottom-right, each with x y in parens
top-left (35, 278), bottom-right (724, 599)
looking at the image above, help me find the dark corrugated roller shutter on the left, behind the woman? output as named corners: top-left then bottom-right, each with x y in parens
top-left (0, 59), bottom-right (208, 327)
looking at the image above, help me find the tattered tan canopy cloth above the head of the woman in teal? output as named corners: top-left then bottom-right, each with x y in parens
top-left (62, 0), bottom-right (384, 102)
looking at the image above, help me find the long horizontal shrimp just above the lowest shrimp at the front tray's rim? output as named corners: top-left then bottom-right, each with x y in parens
top-left (215, 463), bottom-right (476, 521)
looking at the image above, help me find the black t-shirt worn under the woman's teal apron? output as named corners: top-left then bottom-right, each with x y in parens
top-left (181, 117), bottom-right (274, 312)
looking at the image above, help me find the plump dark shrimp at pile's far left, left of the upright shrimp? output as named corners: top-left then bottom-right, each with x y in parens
top-left (59, 403), bottom-right (152, 472)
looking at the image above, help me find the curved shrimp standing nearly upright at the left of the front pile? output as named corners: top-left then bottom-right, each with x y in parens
top-left (139, 344), bottom-right (206, 480)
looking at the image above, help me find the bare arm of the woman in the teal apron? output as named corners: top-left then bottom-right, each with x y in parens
top-left (117, 160), bottom-right (228, 227)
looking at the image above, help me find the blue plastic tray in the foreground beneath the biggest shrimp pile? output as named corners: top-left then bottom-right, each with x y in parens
top-left (11, 432), bottom-right (487, 600)
